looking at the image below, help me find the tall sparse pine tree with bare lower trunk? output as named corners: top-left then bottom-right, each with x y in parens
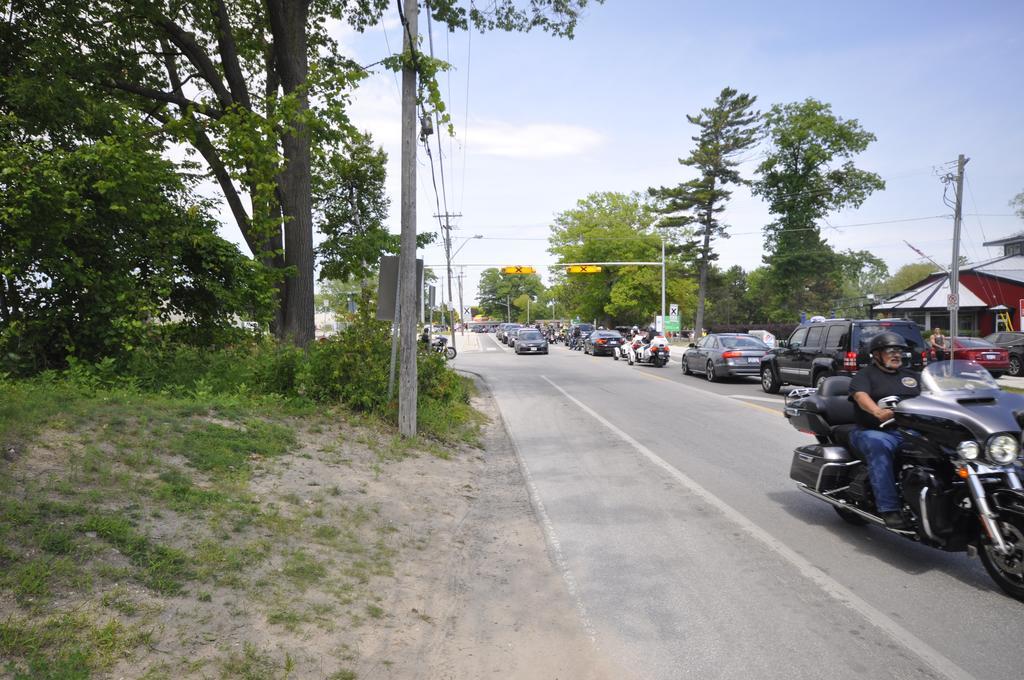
top-left (650, 87), bottom-right (761, 337)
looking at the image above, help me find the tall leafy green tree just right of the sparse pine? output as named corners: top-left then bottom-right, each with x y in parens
top-left (754, 98), bottom-right (885, 321)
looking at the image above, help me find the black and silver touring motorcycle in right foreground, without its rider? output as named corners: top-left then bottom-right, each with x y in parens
top-left (784, 360), bottom-right (1024, 601)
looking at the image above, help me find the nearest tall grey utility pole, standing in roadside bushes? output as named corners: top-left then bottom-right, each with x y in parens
top-left (398, 0), bottom-right (419, 437)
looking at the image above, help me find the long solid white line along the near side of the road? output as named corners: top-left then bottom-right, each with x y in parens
top-left (541, 376), bottom-right (974, 680)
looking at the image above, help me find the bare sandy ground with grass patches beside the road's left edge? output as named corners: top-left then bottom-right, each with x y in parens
top-left (0, 374), bottom-right (628, 680)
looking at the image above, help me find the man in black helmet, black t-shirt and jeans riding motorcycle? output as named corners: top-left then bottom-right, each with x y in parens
top-left (850, 333), bottom-right (921, 529)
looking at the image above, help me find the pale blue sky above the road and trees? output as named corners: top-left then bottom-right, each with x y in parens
top-left (288, 0), bottom-right (1024, 304)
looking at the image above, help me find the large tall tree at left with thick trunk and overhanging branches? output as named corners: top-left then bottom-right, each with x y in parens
top-left (6, 0), bottom-right (602, 344)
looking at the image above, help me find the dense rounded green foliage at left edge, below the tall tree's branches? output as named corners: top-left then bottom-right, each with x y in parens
top-left (0, 117), bottom-right (271, 374)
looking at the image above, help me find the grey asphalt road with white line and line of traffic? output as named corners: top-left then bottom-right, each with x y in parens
top-left (455, 334), bottom-right (1024, 679)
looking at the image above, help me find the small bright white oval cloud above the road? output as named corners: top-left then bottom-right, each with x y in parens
top-left (466, 122), bottom-right (604, 159)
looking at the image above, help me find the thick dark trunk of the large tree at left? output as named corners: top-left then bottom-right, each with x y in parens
top-left (267, 0), bottom-right (314, 347)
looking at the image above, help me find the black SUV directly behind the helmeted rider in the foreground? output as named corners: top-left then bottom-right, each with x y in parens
top-left (761, 318), bottom-right (928, 394)
